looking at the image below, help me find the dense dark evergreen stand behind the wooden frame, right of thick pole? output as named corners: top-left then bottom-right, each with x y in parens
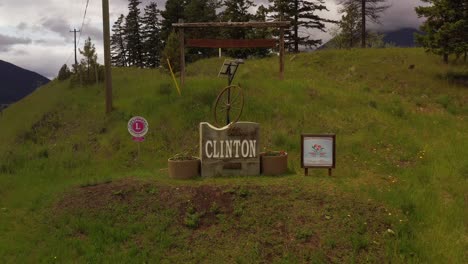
top-left (111, 0), bottom-right (342, 67)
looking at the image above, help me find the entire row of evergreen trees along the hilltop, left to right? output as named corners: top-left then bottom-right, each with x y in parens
top-left (59, 0), bottom-right (468, 83)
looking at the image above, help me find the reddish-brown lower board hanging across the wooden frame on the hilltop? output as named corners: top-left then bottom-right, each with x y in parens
top-left (186, 39), bottom-right (276, 48)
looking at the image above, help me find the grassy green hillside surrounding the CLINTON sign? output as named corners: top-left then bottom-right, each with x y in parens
top-left (0, 49), bottom-right (468, 263)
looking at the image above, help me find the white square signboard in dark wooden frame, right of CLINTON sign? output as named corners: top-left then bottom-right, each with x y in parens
top-left (301, 134), bottom-right (336, 175)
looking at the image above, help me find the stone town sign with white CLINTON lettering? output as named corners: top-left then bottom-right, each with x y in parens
top-left (200, 122), bottom-right (260, 177)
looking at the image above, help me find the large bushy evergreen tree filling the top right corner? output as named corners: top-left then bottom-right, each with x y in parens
top-left (416, 0), bottom-right (468, 63)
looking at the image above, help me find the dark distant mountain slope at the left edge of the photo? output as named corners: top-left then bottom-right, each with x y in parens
top-left (0, 60), bottom-right (50, 105)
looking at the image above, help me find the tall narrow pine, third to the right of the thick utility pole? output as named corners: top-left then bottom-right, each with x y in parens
top-left (141, 2), bottom-right (162, 68)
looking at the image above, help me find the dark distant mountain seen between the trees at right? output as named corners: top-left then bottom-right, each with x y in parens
top-left (318, 28), bottom-right (423, 50)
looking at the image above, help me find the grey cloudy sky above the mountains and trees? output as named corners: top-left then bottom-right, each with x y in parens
top-left (0, 0), bottom-right (421, 78)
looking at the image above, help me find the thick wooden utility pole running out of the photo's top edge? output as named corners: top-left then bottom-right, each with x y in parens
top-left (102, 0), bottom-right (112, 114)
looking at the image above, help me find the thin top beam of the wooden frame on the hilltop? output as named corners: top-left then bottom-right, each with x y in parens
top-left (172, 21), bottom-right (291, 28)
